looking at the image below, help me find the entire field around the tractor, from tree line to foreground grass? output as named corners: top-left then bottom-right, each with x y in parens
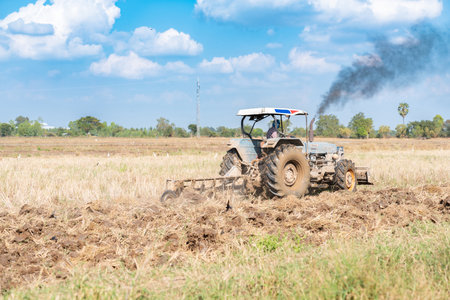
top-left (0, 137), bottom-right (450, 299)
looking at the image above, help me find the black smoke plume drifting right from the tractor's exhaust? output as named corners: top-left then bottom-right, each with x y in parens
top-left (317, 24), bottom-right (449, 115)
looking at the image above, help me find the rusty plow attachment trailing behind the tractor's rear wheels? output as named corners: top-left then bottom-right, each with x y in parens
top-left (160, 176), bottom-right (245, 203)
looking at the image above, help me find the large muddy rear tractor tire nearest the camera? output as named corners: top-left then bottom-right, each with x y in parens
top-left (260, 145), bottom-right (310, 197)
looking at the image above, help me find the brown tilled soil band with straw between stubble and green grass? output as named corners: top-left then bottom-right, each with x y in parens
top-left (0, 186), bottom-right (450, 290)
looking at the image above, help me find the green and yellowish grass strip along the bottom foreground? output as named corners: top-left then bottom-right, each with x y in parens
top-left (4, 223), bottom-right (450, 299)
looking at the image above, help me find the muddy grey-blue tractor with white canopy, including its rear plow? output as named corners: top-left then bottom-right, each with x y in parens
top-left (161, 107), bottom-right (372, 202)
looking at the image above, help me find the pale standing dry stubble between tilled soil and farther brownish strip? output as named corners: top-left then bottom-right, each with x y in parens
top-left (0, 150), bottom-right (450, 211)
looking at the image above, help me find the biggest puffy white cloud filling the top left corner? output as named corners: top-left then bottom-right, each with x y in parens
top-left (0, 0), bottom-right (120, 59)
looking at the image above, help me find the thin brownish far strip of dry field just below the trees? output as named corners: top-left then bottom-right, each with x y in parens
top-left (0, 137), bottom-right (450, 157)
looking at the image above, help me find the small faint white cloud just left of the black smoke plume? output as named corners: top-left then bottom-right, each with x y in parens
top-left (282, 48), bottom-right (339, 73)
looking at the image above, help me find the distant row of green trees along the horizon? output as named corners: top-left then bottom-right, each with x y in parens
top-left (0, 103), bottom-right (450, 138)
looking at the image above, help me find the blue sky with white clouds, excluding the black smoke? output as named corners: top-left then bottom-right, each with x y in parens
top-left (0, 0), bottom-right (450, 128)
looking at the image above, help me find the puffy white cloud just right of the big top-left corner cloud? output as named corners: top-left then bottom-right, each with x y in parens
top-left (129, 26), bottom-right (203, 56)
